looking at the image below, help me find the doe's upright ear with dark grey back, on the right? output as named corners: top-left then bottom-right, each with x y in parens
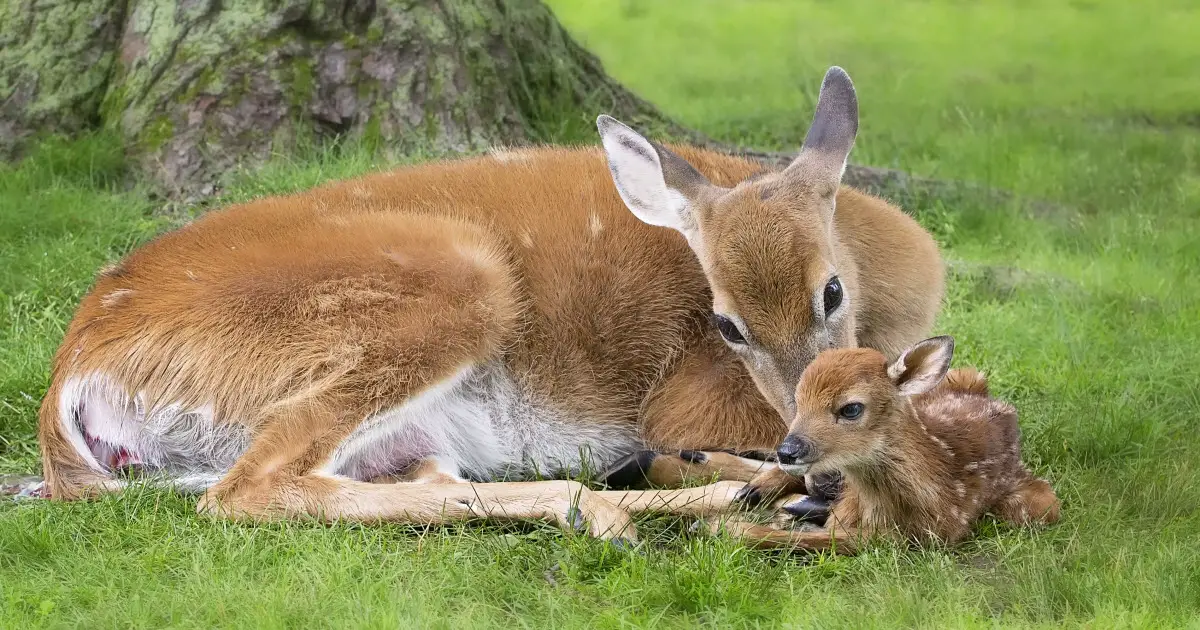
top-left (784, 66), bottom-right (858, 194)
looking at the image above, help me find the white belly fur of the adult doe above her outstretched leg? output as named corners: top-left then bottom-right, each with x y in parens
top-left (322, 365), bottom-right (641, 481)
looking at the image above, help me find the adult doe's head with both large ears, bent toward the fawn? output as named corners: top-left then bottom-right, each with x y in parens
top-left (596, 67), bottom-right (858, 420)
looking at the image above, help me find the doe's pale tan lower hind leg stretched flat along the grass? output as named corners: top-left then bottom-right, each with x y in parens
top-left (197, 388), bottom-right (636, 539)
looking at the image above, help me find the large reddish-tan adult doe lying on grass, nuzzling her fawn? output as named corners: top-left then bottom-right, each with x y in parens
top-left (40, 68), bottom-right (943, 536)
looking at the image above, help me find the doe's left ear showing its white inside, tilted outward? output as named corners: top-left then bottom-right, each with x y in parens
top-left (596, 116), bottom-right (714, 241)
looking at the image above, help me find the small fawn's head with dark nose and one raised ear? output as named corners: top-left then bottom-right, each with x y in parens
top-left (779, 336), bottom-right (954, 476)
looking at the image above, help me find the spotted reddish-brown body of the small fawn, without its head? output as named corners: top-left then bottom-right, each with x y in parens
top-left (832, 370), bottom-right (1058, 544)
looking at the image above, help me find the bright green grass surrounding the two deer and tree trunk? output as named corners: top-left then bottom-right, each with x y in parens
top-left (0, 0), bottom-right (1200, 628)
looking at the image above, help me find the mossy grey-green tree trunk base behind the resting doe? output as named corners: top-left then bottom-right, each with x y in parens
top-left (0, 0), bottom-right (684, 198)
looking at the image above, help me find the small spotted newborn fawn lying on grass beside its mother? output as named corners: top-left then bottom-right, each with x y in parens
top-left (727, 337), bottom-right (1058, 551)
